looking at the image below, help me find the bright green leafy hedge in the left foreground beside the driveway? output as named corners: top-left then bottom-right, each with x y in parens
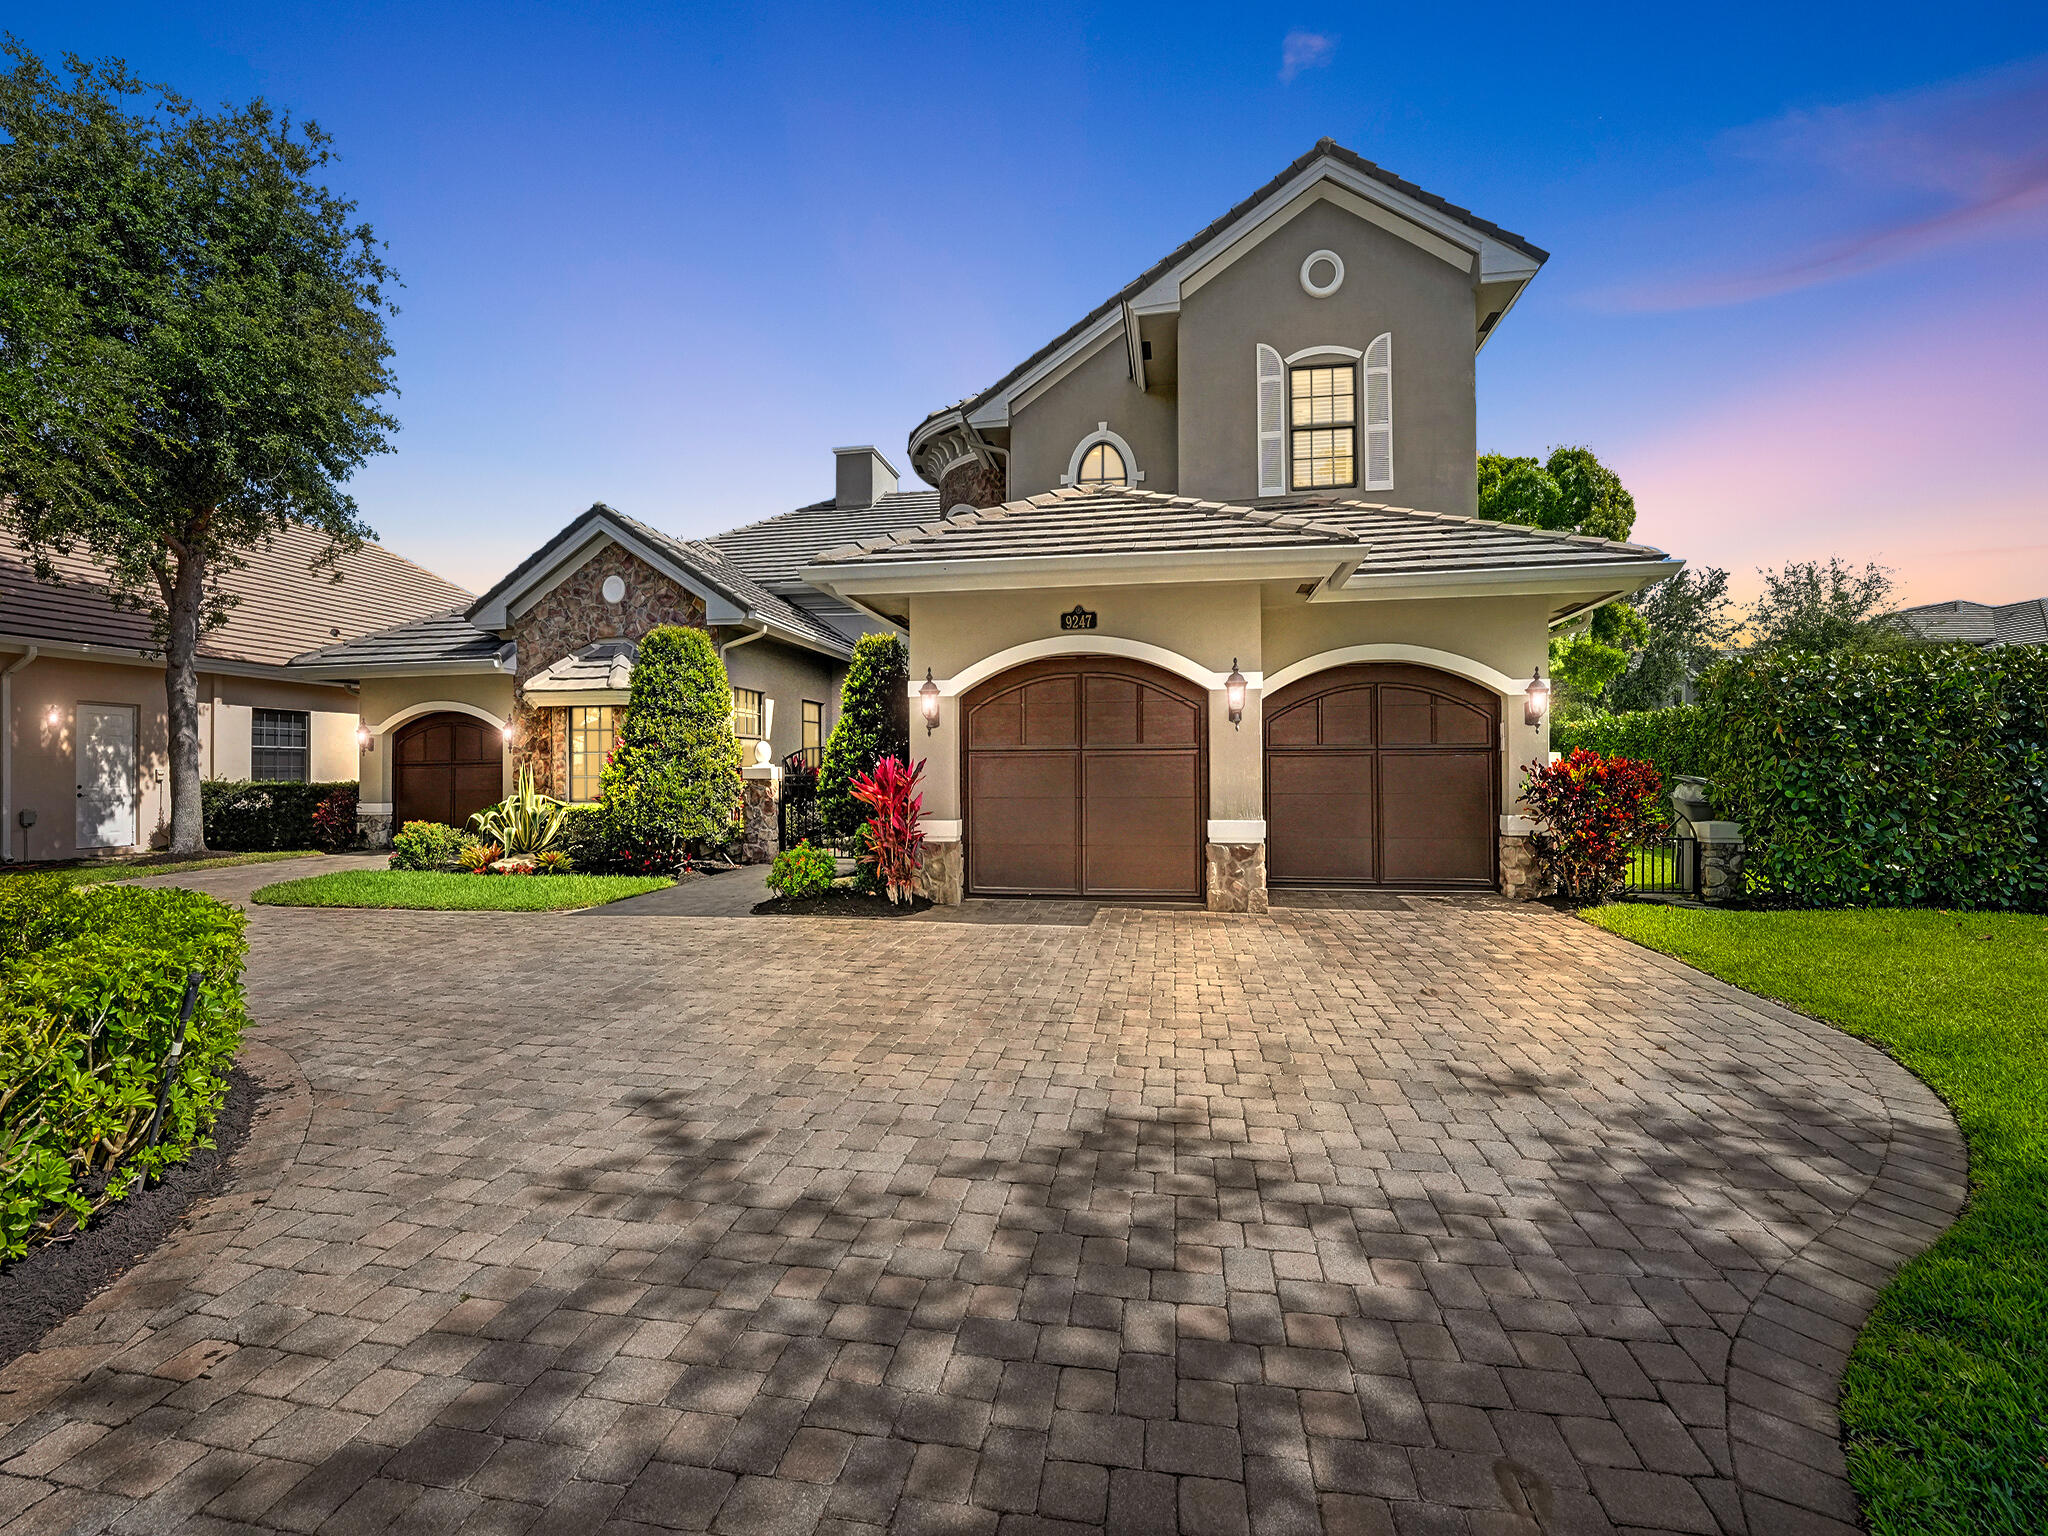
top-left (0, 877), bottom-right (248, 1257)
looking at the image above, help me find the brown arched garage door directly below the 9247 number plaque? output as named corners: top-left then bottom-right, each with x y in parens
top-left (961, 657), bottom-right (1208, 897)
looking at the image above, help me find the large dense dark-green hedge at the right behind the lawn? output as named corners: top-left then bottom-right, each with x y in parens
top-left (1706, 645), bottom-right (2048, 911)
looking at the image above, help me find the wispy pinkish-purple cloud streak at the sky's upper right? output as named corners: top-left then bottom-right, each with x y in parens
top-left (1616, 59), bottom-right (2048, 309)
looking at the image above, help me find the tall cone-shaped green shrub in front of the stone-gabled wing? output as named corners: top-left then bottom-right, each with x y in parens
top-left (598, 625), bottom-right (739, 868)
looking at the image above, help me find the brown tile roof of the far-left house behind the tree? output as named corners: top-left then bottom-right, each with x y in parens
top-left (0, 526), bottom-right (469, 666)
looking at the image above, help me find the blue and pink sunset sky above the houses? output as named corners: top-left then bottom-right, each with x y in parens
top-left (8, 0), bottom-right (2048, 600)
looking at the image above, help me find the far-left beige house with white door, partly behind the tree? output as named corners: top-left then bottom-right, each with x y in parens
top-left (0, 528), bottom-right (469, 862)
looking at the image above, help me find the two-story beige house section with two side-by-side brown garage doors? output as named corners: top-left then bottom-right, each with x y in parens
top-left (805, 139), bottom-right (1679, 909)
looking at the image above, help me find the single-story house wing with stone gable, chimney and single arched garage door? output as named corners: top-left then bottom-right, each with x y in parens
top-left (291, 446), bottom-right (938, 842)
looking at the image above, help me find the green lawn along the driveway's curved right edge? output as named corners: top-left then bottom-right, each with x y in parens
top-left (1585, 905), bottom-right (2048, 1536)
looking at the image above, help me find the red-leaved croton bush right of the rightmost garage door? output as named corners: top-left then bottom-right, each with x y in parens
top-left (1522, 748), bottom-right (1665, 901)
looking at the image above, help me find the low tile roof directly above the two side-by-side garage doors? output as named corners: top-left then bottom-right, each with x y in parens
top-left (811, 485), bottom-right (1667, 575)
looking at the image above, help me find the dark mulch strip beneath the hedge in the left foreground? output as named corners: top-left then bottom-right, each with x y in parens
top-left (0, 1067), bottom-right (262, 1366)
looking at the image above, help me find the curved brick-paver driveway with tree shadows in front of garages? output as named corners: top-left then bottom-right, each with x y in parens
top-left (0, 870), bottom-right (1962, 1536)
